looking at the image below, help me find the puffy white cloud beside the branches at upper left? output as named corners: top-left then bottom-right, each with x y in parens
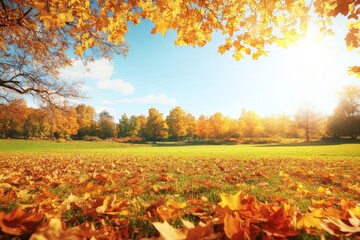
top-left (61, 59), bottom-right (135, 94)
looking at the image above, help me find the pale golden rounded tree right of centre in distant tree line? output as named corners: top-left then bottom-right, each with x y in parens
top-left (239, 109), bottom-right (262, 138)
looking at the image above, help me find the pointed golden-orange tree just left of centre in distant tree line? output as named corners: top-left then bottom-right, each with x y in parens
top-left (146, 108), bottom-right (168, 143)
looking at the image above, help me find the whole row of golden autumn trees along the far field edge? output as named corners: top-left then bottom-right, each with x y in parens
top-left (0, 86), bottom-right (360, 142)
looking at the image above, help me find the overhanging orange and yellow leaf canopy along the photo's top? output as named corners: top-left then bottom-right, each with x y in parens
top-left (0, 0), bottom-right (360, 103)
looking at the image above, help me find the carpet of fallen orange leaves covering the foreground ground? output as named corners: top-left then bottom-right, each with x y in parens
top-left (0, 154), bottom-right (360, 239)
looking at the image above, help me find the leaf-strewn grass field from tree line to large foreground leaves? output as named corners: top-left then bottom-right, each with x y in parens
top-left (0, 140), bottom-right (360, 239)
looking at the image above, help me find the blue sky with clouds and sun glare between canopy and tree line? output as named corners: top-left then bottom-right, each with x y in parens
top-left (57, 15), bottom-right (360, 121)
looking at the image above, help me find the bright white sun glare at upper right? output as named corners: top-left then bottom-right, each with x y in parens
top-left (286, 31), bottom-right (339, 113)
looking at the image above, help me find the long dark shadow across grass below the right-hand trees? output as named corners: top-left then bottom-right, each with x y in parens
top-left (256, 139), bottom-right (360, 147)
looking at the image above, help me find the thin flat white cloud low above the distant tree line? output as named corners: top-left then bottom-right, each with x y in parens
top-left (103, 94), bottom-right (176, 106)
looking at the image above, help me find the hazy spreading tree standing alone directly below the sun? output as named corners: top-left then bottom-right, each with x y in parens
top-left (295, 104), bottom-right (324, 142)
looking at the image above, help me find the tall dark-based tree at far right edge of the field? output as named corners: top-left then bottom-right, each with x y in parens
top-left (329, 85), bottom-right (360, 139)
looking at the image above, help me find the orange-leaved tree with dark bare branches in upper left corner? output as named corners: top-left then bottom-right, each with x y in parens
top-left (0, 0), bottom-right (127, 105)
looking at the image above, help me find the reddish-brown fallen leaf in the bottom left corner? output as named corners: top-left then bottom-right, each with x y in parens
top-left (0, 207), bottom-right (44, 236)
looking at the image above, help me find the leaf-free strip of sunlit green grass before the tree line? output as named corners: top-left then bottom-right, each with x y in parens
top-left (0, 140), bottom-right (360, 159)
